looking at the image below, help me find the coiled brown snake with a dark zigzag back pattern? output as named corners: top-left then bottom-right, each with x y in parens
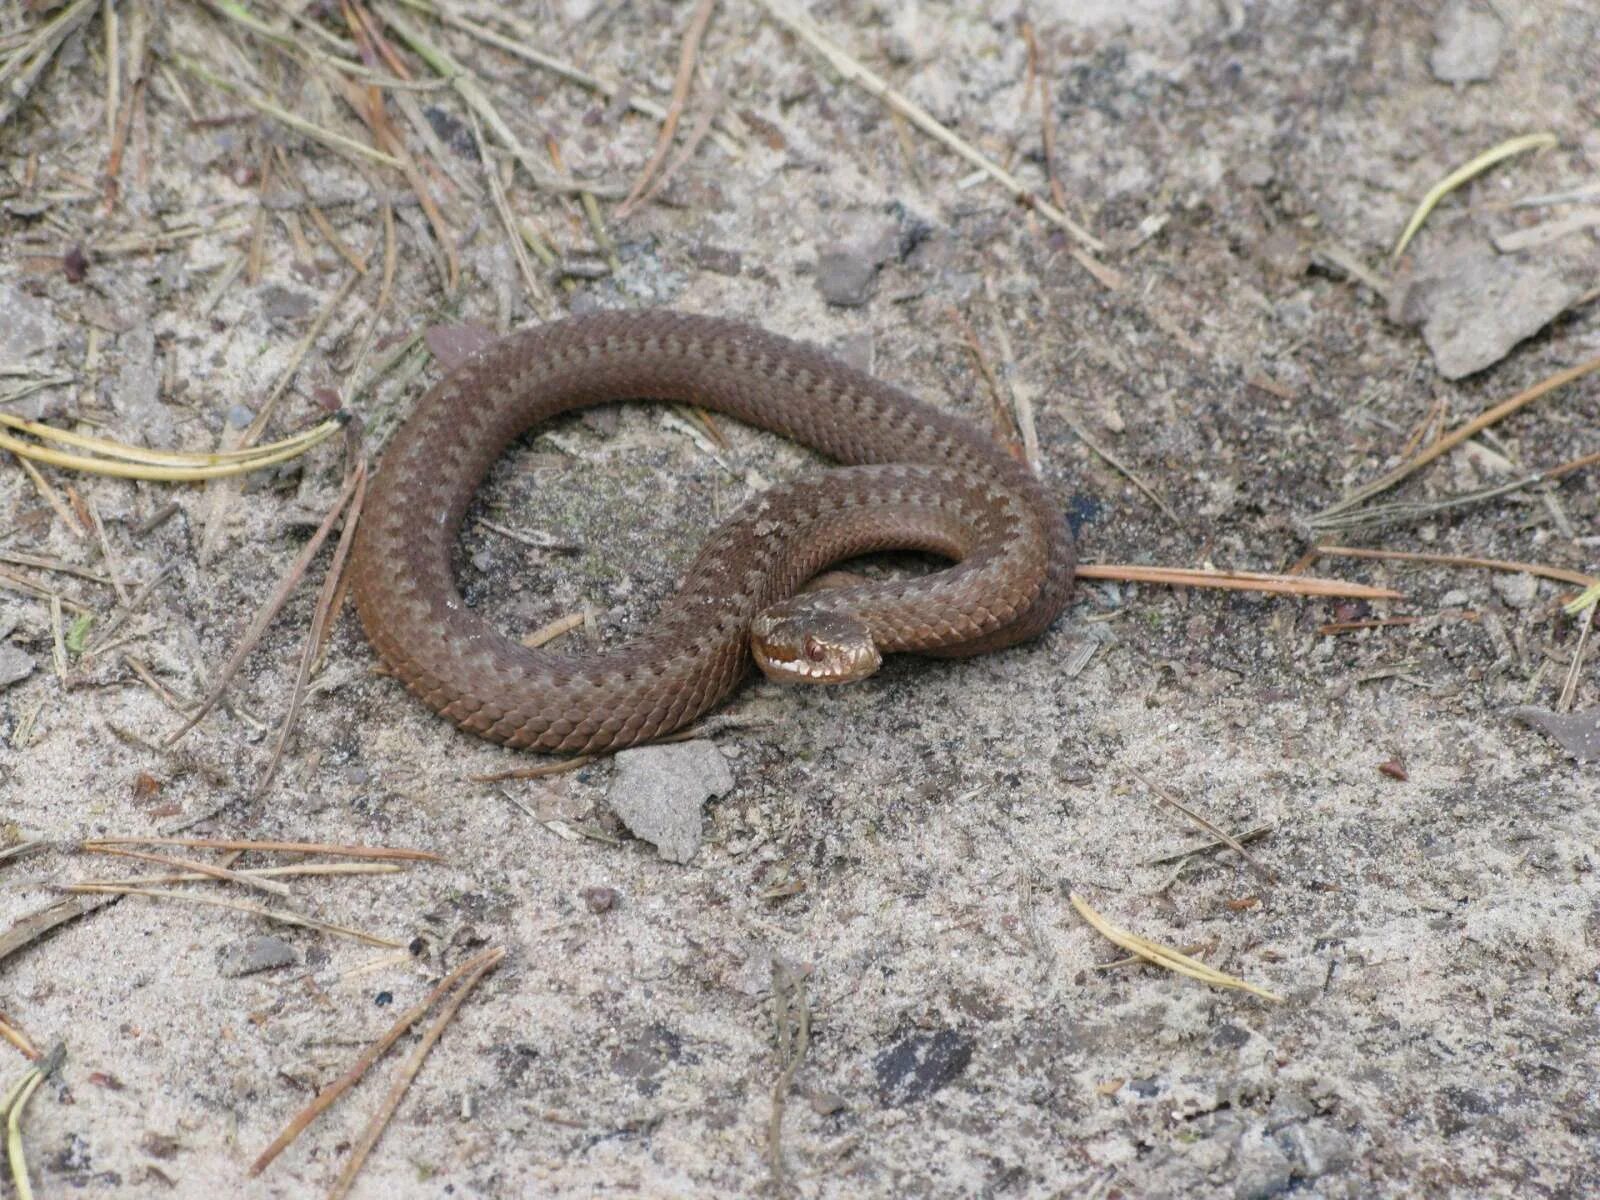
top-left (350, 310), bottom-right (1072, 752)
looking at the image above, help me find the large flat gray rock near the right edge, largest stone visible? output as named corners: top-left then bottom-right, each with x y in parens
top-left (1390, 222), bottom-right (1600, 379)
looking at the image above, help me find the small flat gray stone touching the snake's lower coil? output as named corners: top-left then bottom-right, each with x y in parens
top-left (606, 741), bottom-right (733, 862)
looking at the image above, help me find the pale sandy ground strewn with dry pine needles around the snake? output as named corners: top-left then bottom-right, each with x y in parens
top-left (0, 0), bottom-right (1600, 1197)
